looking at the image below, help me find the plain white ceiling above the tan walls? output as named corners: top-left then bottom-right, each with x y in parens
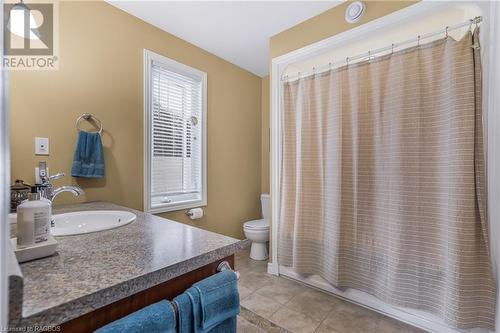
top-left (108, 0), bottom-right (342, 76)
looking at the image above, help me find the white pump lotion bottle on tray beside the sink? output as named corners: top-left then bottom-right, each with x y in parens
top-left (17, 190), bottom-right (52, 247)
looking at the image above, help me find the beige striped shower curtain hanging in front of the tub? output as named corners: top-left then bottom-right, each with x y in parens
top-left (278, 29), bottom-right (495, 329)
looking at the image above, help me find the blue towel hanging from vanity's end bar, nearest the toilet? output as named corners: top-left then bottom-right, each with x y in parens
top-left (174, 271), bottom-right (240, 333)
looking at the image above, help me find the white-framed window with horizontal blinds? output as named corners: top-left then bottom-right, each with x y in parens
top-left (144, 51), bottom-right (206, 212)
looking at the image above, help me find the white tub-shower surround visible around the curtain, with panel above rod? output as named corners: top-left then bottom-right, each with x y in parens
top-left (268, 2), bottom-right (500, 332)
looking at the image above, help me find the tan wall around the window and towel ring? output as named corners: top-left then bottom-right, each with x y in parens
top-left (9, 1), bottom-right (262, 238)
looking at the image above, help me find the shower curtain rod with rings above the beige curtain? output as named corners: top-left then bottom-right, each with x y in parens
top-left (281, 16), bottom-right (483, 82)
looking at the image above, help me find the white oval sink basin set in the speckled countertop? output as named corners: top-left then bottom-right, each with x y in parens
top-left (51, 210), bottom-right (137, 236)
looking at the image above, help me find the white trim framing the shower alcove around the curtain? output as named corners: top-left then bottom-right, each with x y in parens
top-left (268, 1), bottom-right (500, 333)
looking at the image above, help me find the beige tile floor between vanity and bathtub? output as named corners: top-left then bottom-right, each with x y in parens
top-left (235, 250), bottom-right (424, 333)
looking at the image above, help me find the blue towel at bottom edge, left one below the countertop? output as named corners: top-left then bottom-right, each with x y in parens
top-left (94, 301), bottom-right (176, 333)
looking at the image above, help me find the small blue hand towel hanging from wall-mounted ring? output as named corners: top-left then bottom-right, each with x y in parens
top-left (71, 131), bottom-right (104, 178)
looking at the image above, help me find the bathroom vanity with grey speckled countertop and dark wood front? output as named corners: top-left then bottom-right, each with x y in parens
top-left (9, 202), bottom-right (248, 333)
